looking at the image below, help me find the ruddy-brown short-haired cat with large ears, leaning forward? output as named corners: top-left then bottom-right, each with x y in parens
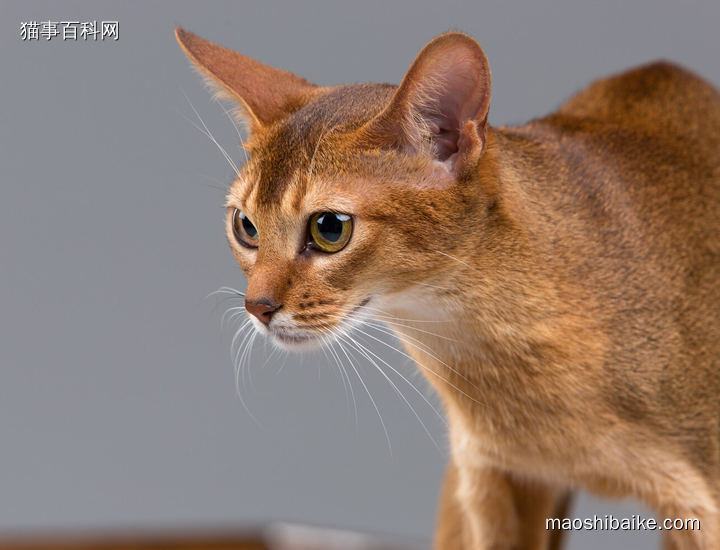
top-left (176, 28), bottom-right (720, 550)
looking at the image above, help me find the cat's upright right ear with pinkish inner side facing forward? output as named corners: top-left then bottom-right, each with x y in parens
top-left (366, 32), bottom-right (490, 169)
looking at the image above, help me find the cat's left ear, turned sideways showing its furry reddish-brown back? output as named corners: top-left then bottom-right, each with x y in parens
top-left (175, 27), bottom-right (319, 135)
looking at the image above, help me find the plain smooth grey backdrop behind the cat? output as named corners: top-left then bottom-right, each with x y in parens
top-left (0, 0), bottom-right (720, 548)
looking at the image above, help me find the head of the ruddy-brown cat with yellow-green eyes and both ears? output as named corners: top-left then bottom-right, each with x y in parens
top-left (176, 28), bottom-right (492, 348)
